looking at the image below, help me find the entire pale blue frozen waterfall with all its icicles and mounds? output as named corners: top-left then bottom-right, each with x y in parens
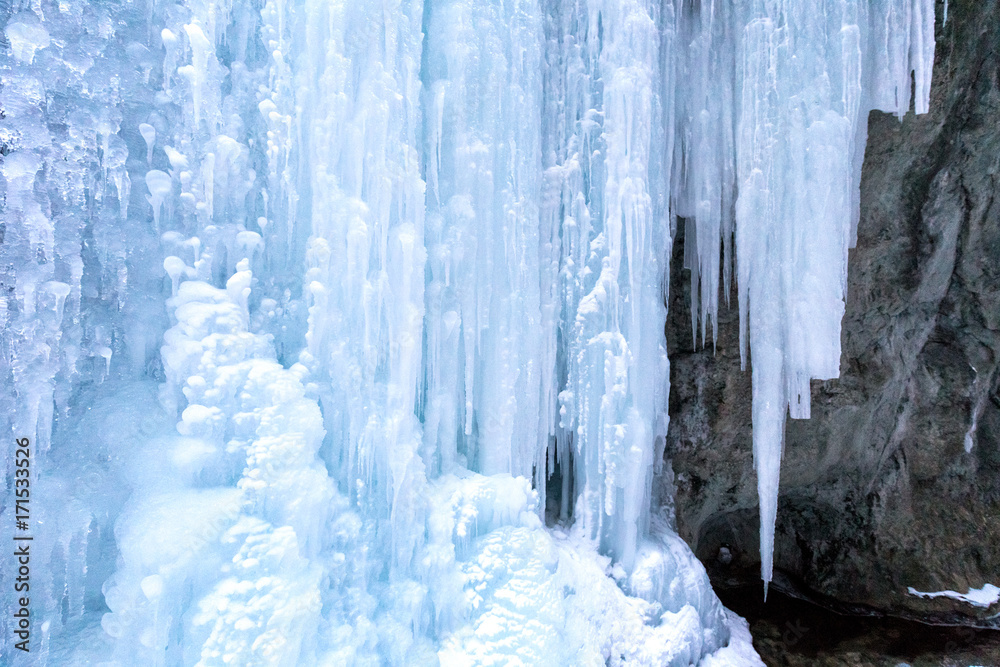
top-left (0, 0), bottom-right (934, 665)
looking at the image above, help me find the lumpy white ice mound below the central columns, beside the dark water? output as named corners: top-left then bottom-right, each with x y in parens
top-left (441, 477), bottom-right (728, 665)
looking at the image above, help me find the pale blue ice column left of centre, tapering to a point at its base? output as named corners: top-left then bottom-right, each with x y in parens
top-left (286, 2), bottom-right (434, 575)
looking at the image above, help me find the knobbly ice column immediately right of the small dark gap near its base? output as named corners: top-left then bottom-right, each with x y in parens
top-left (543, 2), bottom-right (674, 568)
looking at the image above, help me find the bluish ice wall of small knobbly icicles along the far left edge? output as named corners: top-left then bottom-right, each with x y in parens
top-left (0, 3), bottom-right (162, 662)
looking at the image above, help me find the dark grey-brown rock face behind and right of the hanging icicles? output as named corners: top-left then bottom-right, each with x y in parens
top-left (667, 0), bottom-right (1000, 625)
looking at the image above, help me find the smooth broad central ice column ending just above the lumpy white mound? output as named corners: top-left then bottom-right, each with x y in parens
top-left (423, 0), bottom-right (556, 486)
